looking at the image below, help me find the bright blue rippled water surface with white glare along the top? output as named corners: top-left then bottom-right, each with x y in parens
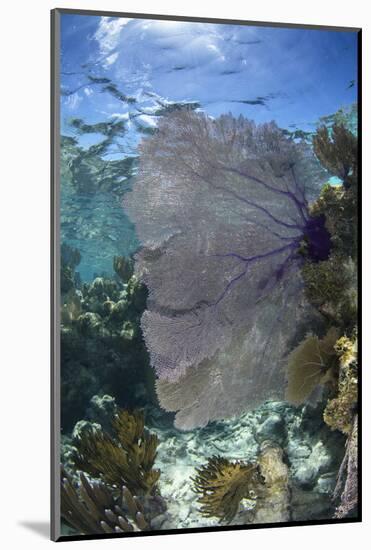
top-left (61, 14), bottom-right (357, 144)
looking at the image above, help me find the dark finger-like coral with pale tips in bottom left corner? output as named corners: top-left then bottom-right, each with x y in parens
top-left (61, 469), bottom-right (150, 535)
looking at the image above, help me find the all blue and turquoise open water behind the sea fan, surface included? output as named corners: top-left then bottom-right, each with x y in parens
top-left (61, 15), bottom-right (357, 281)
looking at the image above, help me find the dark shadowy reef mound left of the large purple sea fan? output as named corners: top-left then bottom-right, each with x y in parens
top-left (61, 246), bottom-right (155, 432)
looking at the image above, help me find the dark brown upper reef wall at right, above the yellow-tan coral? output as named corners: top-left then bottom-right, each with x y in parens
top-left (302, 124), bottom-right (358, 332)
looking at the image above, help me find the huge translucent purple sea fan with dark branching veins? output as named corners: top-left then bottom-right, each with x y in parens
top-left (124, 111), bottom-right (330, 429)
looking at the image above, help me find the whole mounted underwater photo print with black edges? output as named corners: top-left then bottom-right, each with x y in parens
top-left (52, 9), bottom-right (361, 540)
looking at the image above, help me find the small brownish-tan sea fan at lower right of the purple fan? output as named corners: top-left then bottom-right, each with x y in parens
top-left (286, 328), bottom-right (338, 405)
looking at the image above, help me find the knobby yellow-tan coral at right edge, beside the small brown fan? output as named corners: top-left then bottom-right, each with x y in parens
top-left (323, 336), bottom-right (358, 434)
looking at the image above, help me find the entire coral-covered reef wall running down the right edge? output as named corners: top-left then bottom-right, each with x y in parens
top-left (302, 122), bottom-right (358, 517)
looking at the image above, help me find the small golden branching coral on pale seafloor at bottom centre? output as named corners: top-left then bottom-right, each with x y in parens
top-left (192, 456), bottom-right (262, 523)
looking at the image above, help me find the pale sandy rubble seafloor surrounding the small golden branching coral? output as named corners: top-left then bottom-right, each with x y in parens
top-left (62, 396), bottom-right (345, 534)
